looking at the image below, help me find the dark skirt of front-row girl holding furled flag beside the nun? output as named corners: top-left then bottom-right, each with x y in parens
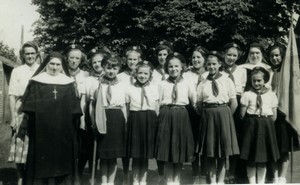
top-left (97, 109), bottom-right (126, 159)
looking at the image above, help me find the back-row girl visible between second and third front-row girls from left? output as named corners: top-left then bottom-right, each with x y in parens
top-left (152, 41), bottom-right (173, 83)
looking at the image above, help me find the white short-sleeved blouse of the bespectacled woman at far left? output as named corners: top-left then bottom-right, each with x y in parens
top-left (8, 63), bottom-right (39, 96)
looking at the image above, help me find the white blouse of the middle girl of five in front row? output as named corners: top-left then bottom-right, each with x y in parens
top-left (159, 79), bottom-right (197, 106)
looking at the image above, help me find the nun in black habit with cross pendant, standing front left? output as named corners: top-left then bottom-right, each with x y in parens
top-left (23, 52), bottom-right (82, 184)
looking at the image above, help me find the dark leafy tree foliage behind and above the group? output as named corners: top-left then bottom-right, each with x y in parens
top-left (32, 0), bottom-right (299, 59)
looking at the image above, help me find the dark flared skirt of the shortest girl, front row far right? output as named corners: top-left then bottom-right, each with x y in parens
top-left (240, 115), bottom-right (279, 162)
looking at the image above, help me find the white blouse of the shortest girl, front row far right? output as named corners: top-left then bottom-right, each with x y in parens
top-left (241, 90), bottom-right (278, 116)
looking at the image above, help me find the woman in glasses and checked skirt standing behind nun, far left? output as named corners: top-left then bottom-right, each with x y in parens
top-left (8, 42), bottom-right (39, 184)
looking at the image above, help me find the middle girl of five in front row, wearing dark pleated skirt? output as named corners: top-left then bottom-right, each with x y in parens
top-left (156, 52), bottom-right (196, 185)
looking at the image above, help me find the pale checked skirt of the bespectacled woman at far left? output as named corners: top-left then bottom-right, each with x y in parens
top-left (8, 113), bottom-right (29, 164)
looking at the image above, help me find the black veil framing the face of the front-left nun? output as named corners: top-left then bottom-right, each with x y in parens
top-left (33, 51), bottom-right (70, 76)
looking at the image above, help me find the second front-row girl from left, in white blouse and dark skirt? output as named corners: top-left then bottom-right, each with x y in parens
top-left (126, 61), bottom-right (159, 185)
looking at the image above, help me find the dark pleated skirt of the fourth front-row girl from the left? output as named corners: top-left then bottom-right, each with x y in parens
top-left (196, 105), bottom-right (239, 158)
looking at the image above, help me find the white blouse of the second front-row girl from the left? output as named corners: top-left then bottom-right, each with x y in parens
top-left (126, 84), bottom-right (159, 111)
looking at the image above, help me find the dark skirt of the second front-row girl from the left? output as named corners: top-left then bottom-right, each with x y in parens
top-left (127, 110), bottom-right (157, 159)
